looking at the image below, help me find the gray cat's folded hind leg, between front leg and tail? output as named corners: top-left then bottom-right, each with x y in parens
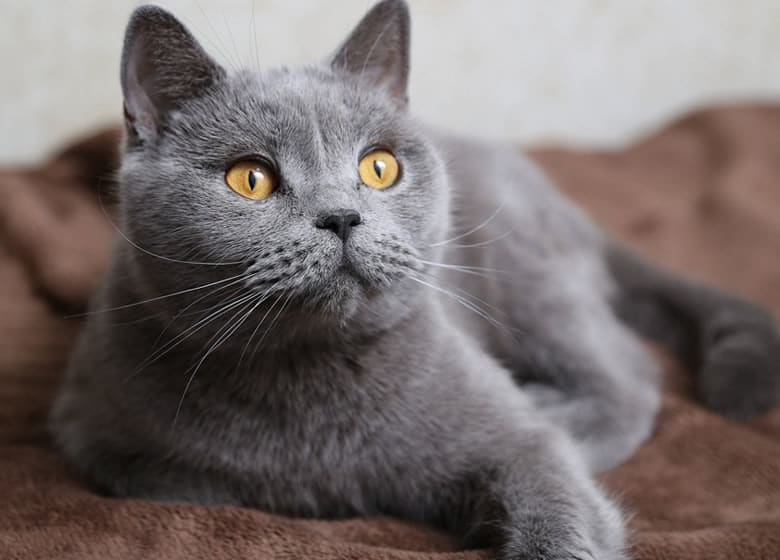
top-left (507, 293), bottom-right (660, 472)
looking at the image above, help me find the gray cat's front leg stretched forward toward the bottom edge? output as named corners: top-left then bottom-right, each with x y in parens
top-left (386, 368), bottom-right (626, 560)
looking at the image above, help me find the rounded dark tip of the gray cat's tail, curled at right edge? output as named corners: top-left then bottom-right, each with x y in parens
top-left (698, 306), bottom-right (780, 419)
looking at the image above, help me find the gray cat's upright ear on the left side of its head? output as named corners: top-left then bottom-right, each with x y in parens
top-left (121, 6), bottom-right (225, 142)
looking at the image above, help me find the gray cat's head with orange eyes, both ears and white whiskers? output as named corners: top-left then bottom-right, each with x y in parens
top-left (120, 0), bottom-right (448, 340)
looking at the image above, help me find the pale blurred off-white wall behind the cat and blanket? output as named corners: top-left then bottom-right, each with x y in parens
top-left (0, 0), bottom-right (780, 164)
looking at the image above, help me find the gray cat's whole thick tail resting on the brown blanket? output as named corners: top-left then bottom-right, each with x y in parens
top-left (607, 244), bottom-right (780, 418)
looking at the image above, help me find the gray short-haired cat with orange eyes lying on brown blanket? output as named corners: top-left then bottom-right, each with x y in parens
top-left (51, 0), bottom-right (780, 560)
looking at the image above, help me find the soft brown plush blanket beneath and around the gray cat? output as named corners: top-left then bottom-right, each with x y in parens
top-left (0, 107), bottom-right (780, 560)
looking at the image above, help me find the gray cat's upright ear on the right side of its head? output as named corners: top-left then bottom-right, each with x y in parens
top-left (331, 0), bottom-right (410, 104)
